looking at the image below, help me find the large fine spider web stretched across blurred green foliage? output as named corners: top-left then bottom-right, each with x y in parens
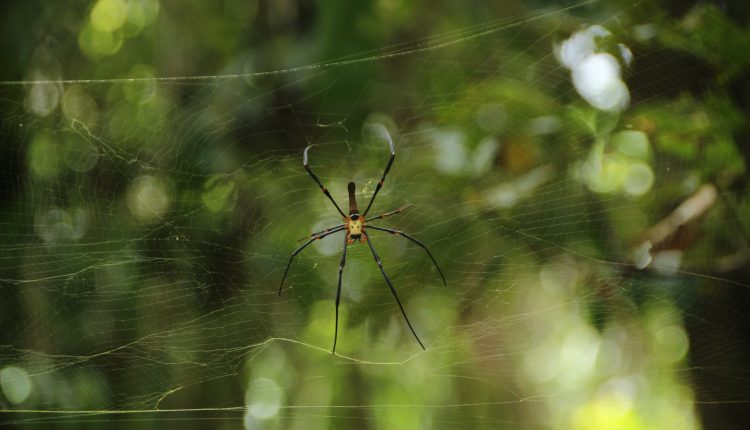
top-left (0, 2), bottom-right (750, 429)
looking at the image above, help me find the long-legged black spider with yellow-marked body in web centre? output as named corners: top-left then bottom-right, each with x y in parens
top-left (279, 137), bottom-right (447, 353)
